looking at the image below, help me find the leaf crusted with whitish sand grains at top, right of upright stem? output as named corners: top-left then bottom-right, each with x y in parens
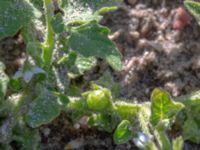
top-left (64, 0), bottom-right (122, 22)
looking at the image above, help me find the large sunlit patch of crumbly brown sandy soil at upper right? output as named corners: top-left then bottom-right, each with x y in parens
top-left (103, 1), bottom-right (200, 101)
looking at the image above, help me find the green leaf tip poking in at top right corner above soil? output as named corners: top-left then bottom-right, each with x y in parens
top-left (184, 0), bottom-right (200, 25)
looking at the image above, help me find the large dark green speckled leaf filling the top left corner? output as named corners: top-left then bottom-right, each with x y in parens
top-left (0, 0), bottom-right (41, 38)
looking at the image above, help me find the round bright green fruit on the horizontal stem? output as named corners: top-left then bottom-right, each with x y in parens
top-left (87, 88), bottom-right (112, 111)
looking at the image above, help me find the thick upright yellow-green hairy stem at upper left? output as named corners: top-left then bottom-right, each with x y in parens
top-left (43, 0), bottom-right (54, 69)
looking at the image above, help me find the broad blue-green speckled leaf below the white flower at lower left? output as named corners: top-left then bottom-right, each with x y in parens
top-left (26, 89), bottom-right (60, 128)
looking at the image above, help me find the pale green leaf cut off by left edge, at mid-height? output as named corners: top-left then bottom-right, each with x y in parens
top-left (0, 62), bottom-right (9, 100)
